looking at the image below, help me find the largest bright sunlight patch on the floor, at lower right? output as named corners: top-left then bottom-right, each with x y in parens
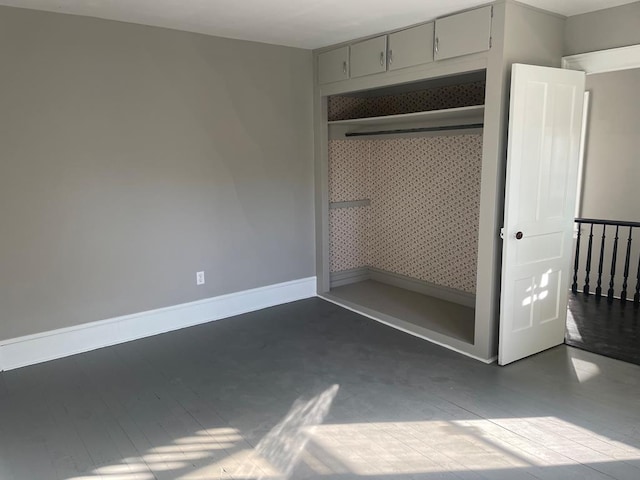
top-left (304, 417), bottom-right (640, 476)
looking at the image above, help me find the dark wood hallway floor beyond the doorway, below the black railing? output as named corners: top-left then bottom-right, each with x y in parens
top-left (565, 293), bottom-right (640, 365)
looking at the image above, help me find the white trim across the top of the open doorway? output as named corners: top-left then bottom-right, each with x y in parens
top-left (562, 45), bottom-right (640, 75)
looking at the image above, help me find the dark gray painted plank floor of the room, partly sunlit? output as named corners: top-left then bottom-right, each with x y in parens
top-left (0, 298), bottom-right (640, 480)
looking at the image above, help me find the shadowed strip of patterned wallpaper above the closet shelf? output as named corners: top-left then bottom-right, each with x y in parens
top-left (328, 82), bottom-right (485, 121)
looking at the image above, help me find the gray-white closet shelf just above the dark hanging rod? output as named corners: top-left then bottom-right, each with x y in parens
top-left (328, 105), bottom-right (484, 127)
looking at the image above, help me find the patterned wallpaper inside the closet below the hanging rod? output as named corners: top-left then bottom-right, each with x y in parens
top-left (329, 135), bottom-right (482, 293)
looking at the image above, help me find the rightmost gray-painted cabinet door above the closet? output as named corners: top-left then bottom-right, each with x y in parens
top-left (434, 6), bottom-right (491, 60)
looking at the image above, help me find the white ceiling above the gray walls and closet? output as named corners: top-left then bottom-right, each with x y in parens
top-left (0, 0), bottom-right (634, 48)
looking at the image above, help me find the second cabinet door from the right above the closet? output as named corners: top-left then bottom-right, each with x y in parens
top-left (387, 23), bottom-right (433, 70)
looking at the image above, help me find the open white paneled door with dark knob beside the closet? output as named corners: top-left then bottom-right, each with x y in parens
top-left (498, 64), bottom-right (585, 365)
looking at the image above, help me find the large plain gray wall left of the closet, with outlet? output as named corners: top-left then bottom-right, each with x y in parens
top-left (0, 7), bottom-right (314, 339)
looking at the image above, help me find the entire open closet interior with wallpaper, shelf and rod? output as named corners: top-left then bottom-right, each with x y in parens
top-left (325, 70), bottom-right (486, 345)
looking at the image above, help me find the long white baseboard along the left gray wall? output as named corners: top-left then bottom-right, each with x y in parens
top-left (0, 277), bottom-right (316, 371)
